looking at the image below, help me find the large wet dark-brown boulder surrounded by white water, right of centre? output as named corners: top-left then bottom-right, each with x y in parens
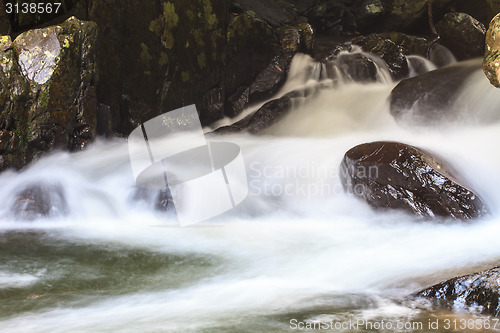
top-left (340, 142), bottom-right (487, 220)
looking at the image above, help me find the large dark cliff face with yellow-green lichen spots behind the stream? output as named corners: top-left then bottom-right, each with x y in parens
top-left (89, 0), bottom-right (313, 135)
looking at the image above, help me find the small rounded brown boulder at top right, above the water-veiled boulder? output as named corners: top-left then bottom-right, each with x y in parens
top-left (436, 13), bottom-right (486, 60)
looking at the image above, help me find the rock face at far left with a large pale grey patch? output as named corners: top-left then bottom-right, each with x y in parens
top-left (0, 18), bottom-right (97, 169)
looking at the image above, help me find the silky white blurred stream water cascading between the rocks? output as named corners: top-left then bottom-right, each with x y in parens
top-left (0, 50), bottom-right (500, 332)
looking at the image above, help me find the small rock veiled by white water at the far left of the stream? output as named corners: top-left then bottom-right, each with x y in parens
top-left (11, 184), bottom-right (68, 220)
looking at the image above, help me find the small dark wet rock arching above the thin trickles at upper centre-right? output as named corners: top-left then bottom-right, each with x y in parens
top-left (352, 34), bottom-right (409, 79)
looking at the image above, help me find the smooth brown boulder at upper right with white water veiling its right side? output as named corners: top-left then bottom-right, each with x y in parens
top-left (390, 60), bottom-right (480, 126)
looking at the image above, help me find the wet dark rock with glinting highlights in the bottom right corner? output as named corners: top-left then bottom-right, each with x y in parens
top-left (416, 267), bottom-right (500, 317)
